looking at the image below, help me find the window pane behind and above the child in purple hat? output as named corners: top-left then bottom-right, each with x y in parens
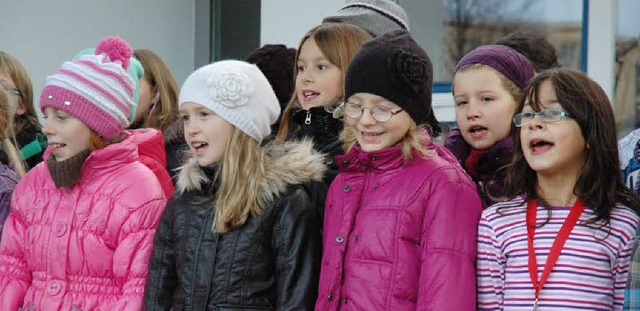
top-left (398, 0), bottom-right (584, 82)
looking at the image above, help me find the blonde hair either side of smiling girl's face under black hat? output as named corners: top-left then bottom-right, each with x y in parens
top-left (340, 120), bottom-right (433, 160)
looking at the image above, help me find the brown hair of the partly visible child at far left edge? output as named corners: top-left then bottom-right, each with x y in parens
top-left (0, 51), bottom-right (42, 134)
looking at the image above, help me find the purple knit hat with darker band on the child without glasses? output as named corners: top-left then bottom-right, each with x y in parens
top-left (453, 45), bottom-right (536, 89)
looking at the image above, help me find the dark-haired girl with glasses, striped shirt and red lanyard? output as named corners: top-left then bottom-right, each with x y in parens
top-left (478, 69), bottom-right (640, 311)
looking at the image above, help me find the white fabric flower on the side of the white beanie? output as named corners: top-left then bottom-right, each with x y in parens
top-left (207, 70), bottom-right (253, 108)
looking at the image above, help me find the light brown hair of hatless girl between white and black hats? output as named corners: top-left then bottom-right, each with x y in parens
top-left (275, 23), bottom-right (372, 142)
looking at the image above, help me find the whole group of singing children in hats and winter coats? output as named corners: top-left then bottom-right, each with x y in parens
top-left (0, 0), bottom-right (640, 310)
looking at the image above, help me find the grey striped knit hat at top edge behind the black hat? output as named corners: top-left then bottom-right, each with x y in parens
top-left (322, 0), bottom-right (409, 37)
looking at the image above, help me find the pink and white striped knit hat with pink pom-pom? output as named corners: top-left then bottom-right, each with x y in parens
top-left (40, 37), bottom-right (136, 140)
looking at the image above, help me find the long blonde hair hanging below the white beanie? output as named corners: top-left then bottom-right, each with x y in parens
top-left (212, 127), bottom-right (267, 233)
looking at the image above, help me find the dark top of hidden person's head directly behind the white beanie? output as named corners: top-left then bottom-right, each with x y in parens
top-left (246, 44), bottom-right (296, 106)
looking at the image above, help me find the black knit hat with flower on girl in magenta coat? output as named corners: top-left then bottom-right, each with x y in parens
top-left (344, 30), bottom-right (441, 135)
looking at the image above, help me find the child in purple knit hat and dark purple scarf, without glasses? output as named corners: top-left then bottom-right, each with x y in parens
top-left (445, 45), bottom-right (535, 207)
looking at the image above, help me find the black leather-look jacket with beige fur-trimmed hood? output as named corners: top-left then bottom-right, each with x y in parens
top-left (145, 141), bottom-right (326, 311)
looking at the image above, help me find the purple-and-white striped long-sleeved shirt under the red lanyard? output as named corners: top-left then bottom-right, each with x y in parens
top-left (477, 197), bottom-right (638, 311)
